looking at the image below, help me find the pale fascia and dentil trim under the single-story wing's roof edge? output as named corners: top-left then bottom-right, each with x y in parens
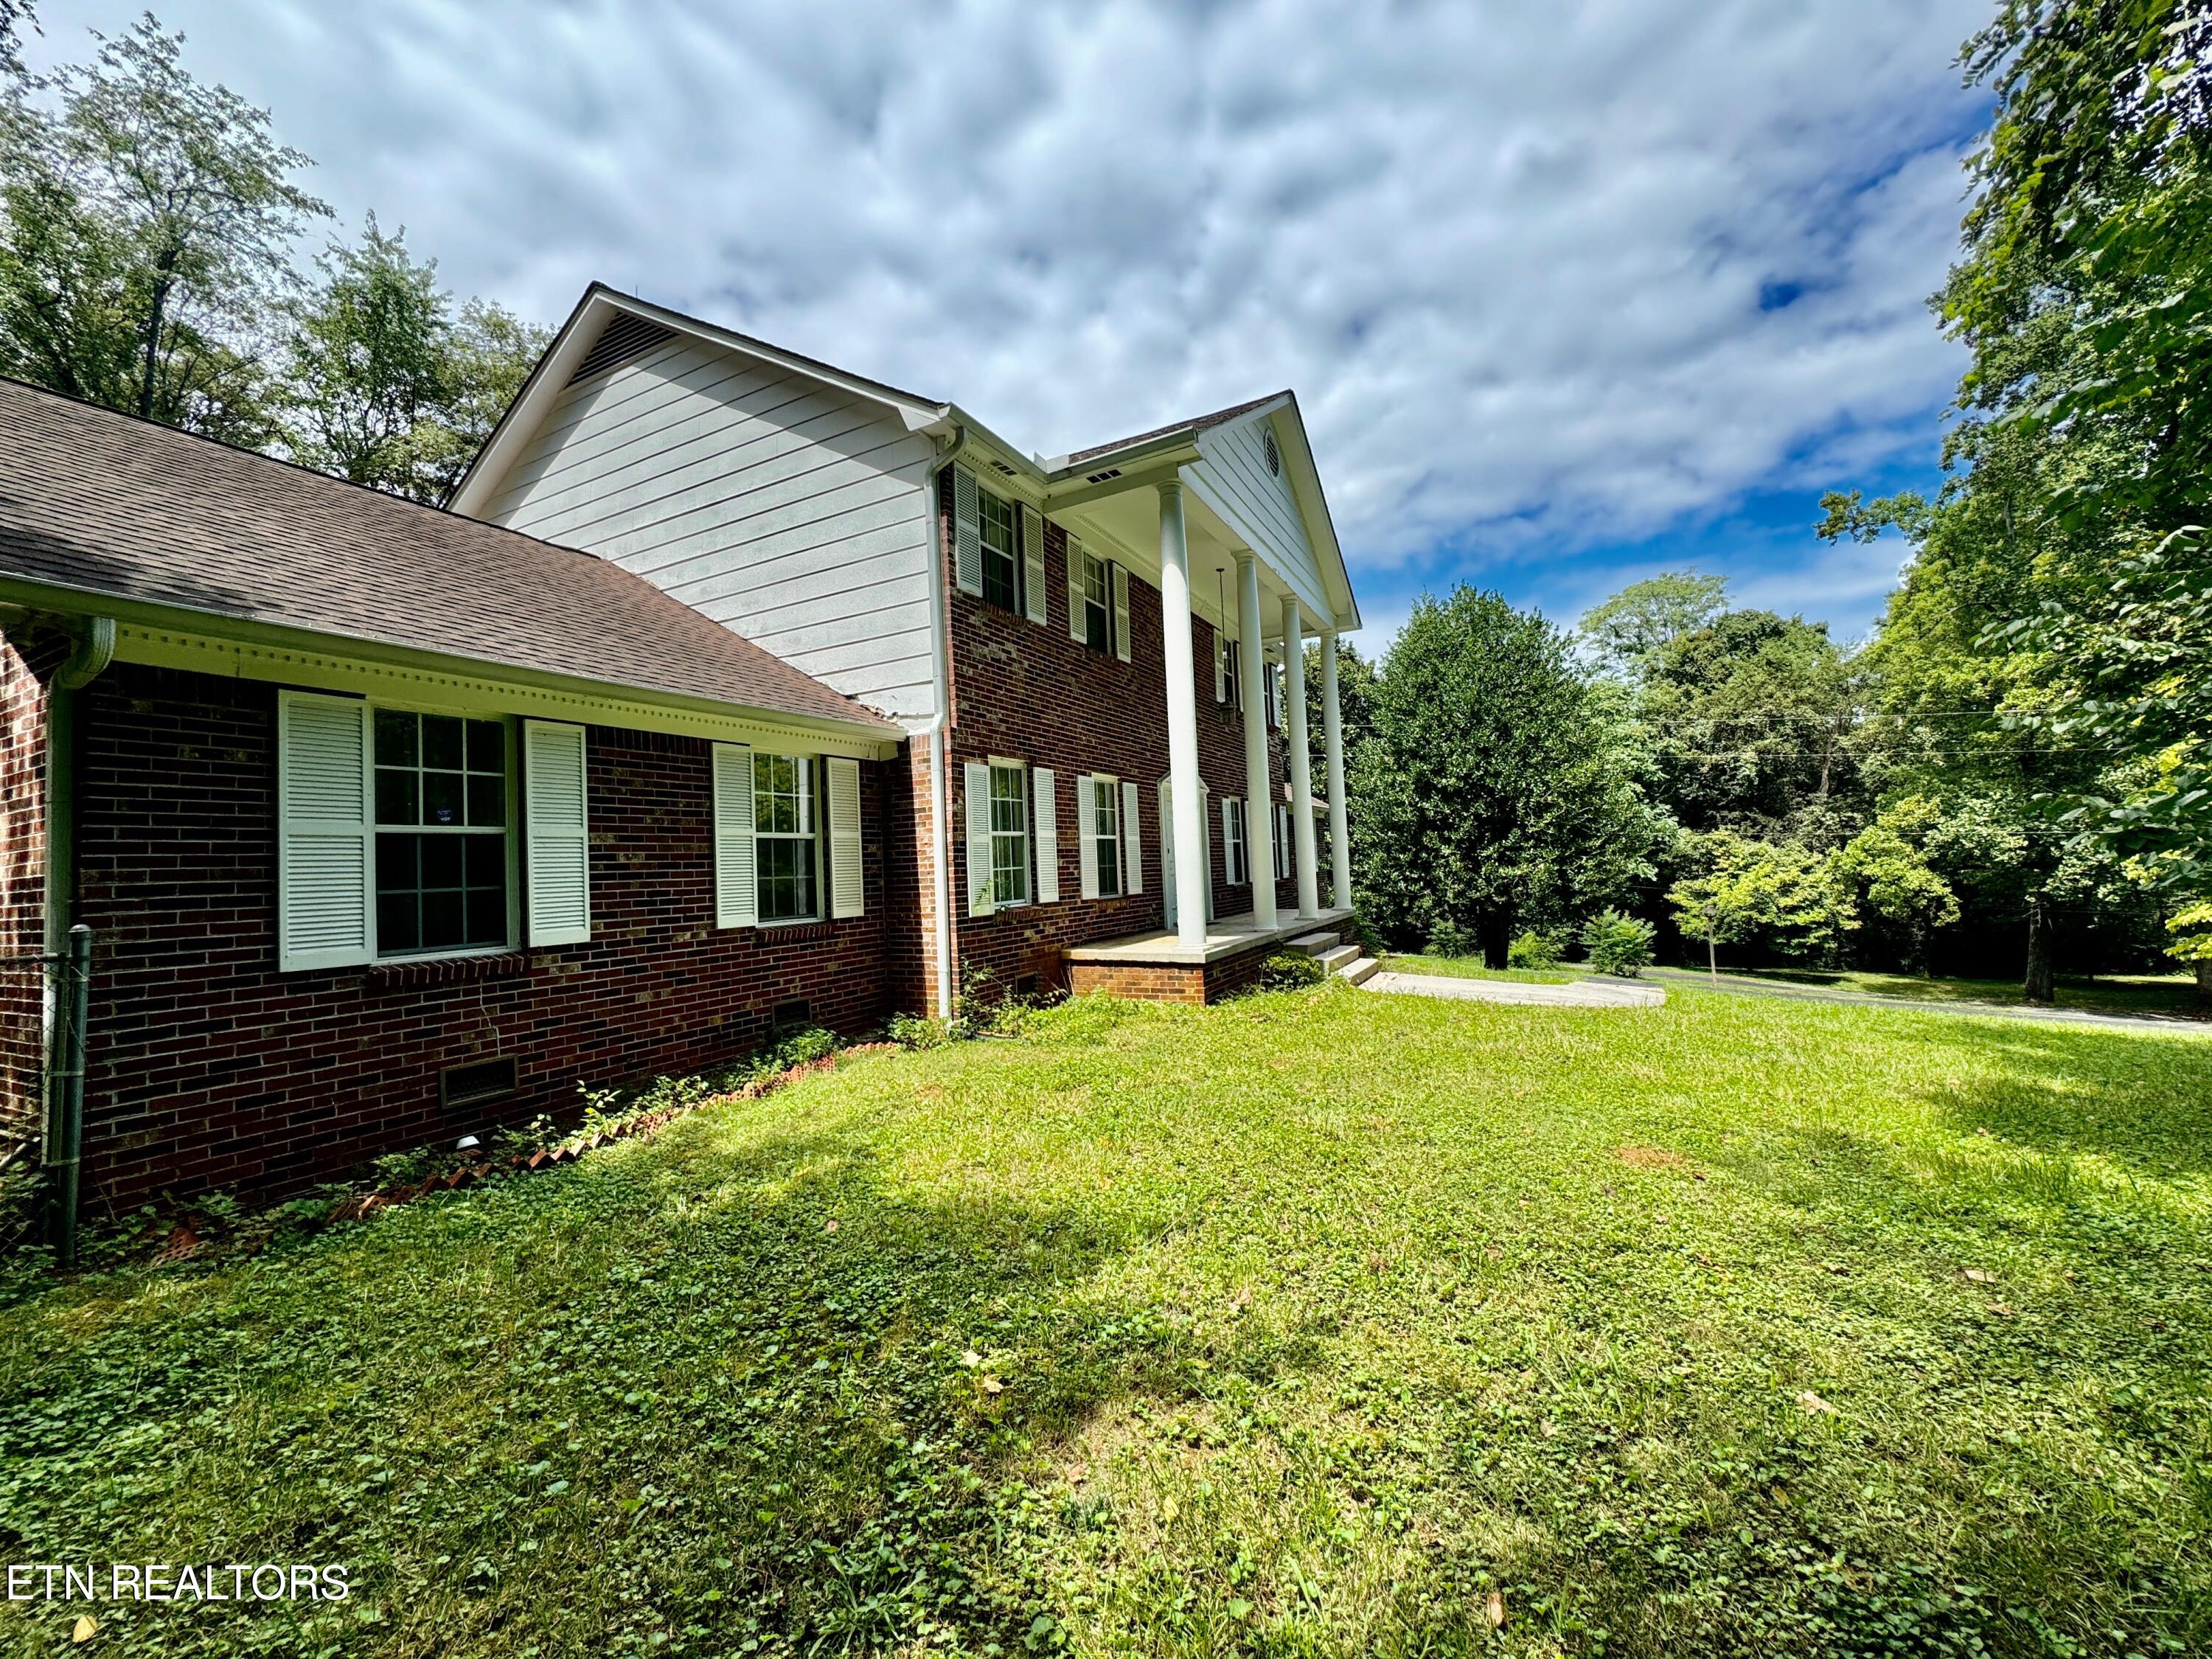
top-left (0, 577), bottom-right (900, 761)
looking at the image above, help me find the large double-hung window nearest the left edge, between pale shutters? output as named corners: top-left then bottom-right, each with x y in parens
top-left (374, 708), bottom-right (513, 956)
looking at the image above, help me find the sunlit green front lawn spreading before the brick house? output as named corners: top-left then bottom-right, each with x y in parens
top-left (0, 987), bottom-right (2212, 1657)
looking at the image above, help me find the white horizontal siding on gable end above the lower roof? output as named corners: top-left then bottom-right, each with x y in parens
top-left (484, 338), bottom-right (933, 717)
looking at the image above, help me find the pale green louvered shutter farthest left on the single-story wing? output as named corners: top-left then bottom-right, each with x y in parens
top-left (276, 692), bottom-right (376, 971)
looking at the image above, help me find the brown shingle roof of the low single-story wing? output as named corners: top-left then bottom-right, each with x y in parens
top-left (0, 378), bottom-right (898, 734)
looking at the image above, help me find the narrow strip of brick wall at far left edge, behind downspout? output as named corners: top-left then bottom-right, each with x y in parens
top-left (0, 635), bottom-right (66, 1146)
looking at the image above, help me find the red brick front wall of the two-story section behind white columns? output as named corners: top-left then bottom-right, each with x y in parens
top-left (938, 473), bottom-right (1298, 987)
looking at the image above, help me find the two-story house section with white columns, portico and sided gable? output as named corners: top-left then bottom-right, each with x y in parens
top-left (453, 288), bottom-right (1358, 1009)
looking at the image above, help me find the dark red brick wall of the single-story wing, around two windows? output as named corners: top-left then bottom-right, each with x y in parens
top-left (77, 666), bottom-right (896, 1208)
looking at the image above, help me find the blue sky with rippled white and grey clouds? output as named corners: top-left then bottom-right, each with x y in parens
top-left (33, 0), bottom-right (1989, 648)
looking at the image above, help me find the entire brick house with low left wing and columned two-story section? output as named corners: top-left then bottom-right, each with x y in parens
top-left (0, 288), bottom-right (1358, 1208)
